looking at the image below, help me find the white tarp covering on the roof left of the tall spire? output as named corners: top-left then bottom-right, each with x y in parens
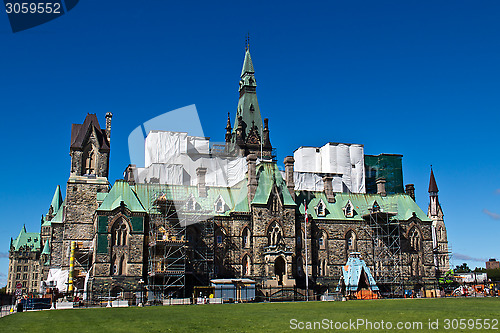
top-left (137, 131), bottom-right (247, 187)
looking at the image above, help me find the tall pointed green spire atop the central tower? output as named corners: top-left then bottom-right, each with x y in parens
top-left (233, 45), bottom-right (263, 138)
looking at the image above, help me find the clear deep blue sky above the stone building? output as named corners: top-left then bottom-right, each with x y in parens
top-left (0, 0), bottom-right (500, 284)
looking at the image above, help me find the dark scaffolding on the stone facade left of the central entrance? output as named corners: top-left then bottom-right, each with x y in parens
top-left (146, 184), bottom-right (213, 302)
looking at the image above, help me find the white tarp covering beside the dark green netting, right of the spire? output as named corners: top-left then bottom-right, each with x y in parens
top-left (294, 143), bottom-right (366, 193)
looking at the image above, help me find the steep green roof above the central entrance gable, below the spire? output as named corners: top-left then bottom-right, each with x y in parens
top-left (252, 162), bottom-right (295, 206)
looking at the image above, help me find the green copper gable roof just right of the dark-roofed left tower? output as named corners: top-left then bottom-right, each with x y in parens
top-left (97, 179), bottom-right (146, 212)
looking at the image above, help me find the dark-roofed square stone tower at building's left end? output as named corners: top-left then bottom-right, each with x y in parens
top-left (51, 113), bottom-right (112, 288)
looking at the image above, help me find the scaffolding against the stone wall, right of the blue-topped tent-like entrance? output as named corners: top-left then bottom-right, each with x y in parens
top-left (363, 202), bottom-right (404, 296)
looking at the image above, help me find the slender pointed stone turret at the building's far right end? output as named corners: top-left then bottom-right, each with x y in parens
top-left (427, 168), bottom-right (450, 276)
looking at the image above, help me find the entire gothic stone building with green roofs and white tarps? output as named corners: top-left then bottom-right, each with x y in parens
top-left (9, 45), bottom-right (449, 297)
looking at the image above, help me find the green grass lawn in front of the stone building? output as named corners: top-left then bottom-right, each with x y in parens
top-left (0, 298), bottom-right (500, 333)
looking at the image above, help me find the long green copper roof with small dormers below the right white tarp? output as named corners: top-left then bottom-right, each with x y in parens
top-left (295, 191), bottom-right (432, 222)
